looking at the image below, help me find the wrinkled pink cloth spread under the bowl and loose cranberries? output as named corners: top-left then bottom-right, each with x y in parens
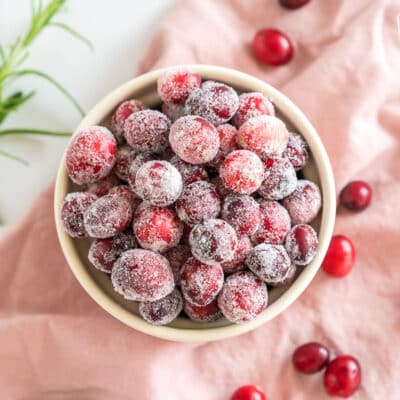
top-left (0, 0), bottom-right (400, 400)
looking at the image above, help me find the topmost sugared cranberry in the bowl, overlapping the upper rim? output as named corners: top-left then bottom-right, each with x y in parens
top-left (157, 68), bottom-right (201, 104)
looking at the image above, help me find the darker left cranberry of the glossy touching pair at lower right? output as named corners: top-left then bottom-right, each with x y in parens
top-left (292, 342), bottom-right (329, 374)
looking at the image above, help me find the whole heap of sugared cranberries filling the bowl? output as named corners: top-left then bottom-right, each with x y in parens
top-left (61, 67), bottom-right (321, 325)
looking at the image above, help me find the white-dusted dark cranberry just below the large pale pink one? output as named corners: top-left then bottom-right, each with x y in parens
top-left (258, 157), bottom-right (297, 200)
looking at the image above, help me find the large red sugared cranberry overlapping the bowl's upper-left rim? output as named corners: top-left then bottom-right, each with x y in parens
top-left (66, 126), bottom-right (117, 185)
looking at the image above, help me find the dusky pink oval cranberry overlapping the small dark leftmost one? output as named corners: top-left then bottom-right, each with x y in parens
top-left (83, 194), bottom-right (132, 239)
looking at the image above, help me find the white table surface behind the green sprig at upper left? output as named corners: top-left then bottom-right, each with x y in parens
top-left (0, 0), bottom-right (175, 236)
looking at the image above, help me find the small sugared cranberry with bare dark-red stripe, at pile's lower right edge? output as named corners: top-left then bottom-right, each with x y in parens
top-left (285, 224), bottom-right (318, 265)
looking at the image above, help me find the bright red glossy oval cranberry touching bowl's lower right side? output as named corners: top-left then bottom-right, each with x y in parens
top-left (322, 235), bottom-right (356, 278)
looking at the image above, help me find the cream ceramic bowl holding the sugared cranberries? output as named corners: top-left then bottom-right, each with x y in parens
top-left (54, 65), bottom-right (335, 342)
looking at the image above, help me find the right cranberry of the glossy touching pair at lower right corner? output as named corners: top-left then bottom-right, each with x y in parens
top-left (324, 355), bottom-right (361, 398)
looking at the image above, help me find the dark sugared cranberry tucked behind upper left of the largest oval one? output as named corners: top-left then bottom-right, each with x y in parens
top-left (88, 232), bottom-right (136, 273)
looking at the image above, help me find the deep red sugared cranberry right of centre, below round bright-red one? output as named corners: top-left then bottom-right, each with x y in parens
top-left (221, 194), bottom-right (261, 236)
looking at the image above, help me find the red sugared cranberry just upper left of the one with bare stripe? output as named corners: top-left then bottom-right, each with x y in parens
top-left (251, 199), bottom-right (290, 244)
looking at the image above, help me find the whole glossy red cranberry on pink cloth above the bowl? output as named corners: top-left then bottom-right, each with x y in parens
top-left (253, 29), bottom-right (294, 66)
